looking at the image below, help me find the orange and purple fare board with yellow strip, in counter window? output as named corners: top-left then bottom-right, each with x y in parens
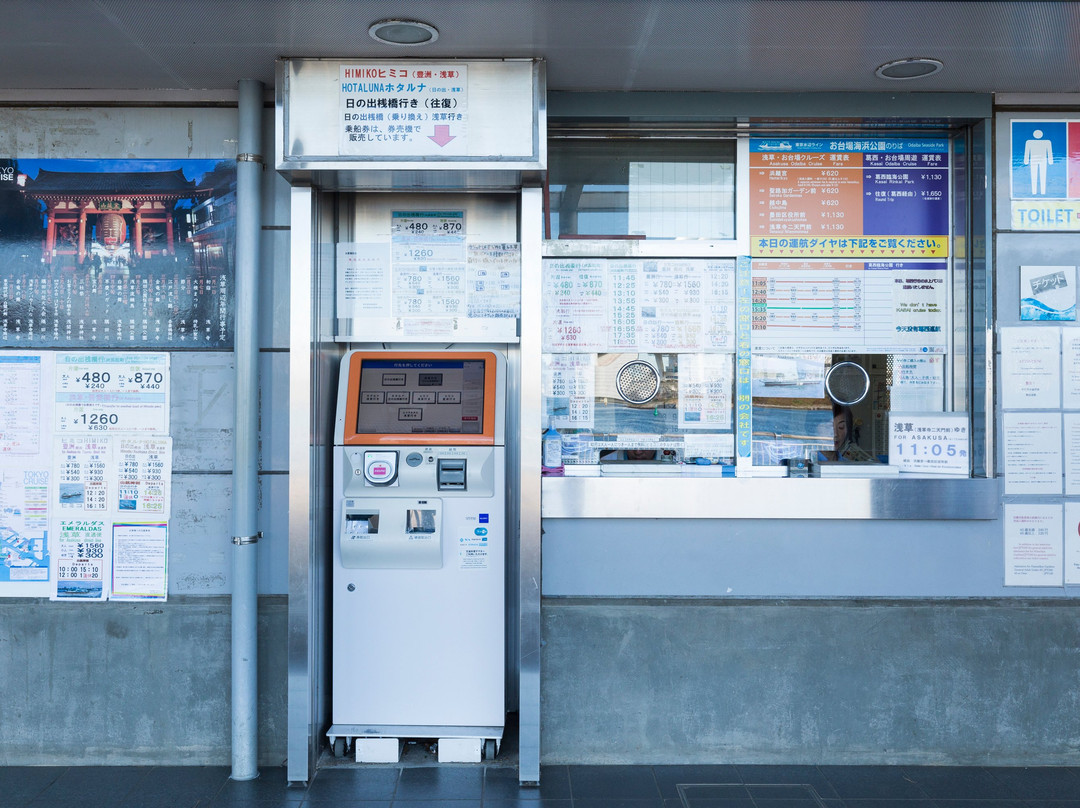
top-left (750, 137), bottom-right (949, 260)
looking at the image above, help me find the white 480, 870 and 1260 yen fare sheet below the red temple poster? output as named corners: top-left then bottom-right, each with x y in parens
top-left (53, 352), bottom-right (168, 434)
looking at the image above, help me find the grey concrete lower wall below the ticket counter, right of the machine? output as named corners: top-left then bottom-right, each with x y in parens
top-left (541, 598), bottom-right (1080, 766)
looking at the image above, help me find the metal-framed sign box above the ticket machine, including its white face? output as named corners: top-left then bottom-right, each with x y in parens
top-left (276, 59), bottom-right (546, 180)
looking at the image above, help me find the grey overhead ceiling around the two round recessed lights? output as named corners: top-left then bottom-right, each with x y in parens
top-left (6, 0), bottom-right (1080, 93)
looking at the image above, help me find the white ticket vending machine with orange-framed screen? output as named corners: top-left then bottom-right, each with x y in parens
top-left (327, 351), bottom-right (505, 763)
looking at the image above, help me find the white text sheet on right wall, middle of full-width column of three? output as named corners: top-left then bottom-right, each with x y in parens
top-left (1002, 413), bottom-right (1063, 495)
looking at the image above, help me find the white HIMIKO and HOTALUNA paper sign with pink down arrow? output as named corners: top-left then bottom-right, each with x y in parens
top-left (338, 63), bottom-right (469, 159)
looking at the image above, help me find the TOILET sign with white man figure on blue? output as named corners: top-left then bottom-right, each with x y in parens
top-left (1011, 120), bottom-right (1080, 230)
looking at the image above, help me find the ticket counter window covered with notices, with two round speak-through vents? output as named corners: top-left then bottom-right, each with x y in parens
top-left (542, 125), bottom-right (984, 476)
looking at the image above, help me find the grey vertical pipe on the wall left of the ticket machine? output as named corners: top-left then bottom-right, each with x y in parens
top-left (232, 80), bottom-right (262, 780)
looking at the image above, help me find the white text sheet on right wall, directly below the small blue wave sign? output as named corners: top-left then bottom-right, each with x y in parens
top-left (999, 326), bottom-right (1062, 409)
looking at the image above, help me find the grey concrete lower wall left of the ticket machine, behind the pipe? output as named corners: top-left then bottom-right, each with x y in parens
top-left (0, 596), bottom-right (287, 766)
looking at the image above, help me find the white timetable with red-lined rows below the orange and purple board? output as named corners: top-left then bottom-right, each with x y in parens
top-left (753, 260), bottom-right (948, 353)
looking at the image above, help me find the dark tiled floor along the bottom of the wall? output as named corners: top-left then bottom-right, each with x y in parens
top-left (0, 764), bottom-right (1080, 808)
